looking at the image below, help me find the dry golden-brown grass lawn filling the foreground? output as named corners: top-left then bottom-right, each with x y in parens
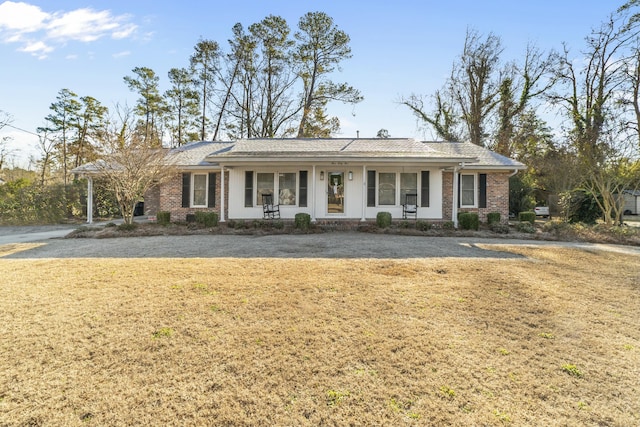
top-left (0, 246), bottom-right (640, 426)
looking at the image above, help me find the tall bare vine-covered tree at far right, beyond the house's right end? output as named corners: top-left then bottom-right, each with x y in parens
top-left (551, 18), bottom-right (628, 225)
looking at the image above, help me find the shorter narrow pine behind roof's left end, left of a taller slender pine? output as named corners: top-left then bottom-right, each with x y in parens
top-left (165, 68), bottom-right (200, 147)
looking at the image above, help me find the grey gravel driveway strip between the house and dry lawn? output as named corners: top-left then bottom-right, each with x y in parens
top-left (3, 232), bottom-right (640, 259)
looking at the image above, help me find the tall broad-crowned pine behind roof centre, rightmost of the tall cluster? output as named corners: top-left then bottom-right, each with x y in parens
top-left (293, 12), bottom-right (363, 138)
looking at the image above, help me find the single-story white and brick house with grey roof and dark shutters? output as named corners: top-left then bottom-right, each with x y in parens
top-left (138, 138), bottom-right (525, 225)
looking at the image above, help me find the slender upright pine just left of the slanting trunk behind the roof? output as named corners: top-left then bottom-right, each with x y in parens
top-left (190, 39), bottom-right (220, 141)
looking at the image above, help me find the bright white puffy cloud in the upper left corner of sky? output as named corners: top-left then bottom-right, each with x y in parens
top-left (0, 1), bottom-right (138, 55)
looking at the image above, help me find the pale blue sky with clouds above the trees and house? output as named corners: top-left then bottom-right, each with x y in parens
top-left (0, 0), bottom-right (624, 167)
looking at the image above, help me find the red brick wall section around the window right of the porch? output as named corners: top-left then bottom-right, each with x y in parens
top-left (442, 172), bottom-right (509, 223)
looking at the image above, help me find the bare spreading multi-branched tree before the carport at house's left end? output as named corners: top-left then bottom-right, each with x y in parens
top-left (95, 108), bottom-right (175, 224)
